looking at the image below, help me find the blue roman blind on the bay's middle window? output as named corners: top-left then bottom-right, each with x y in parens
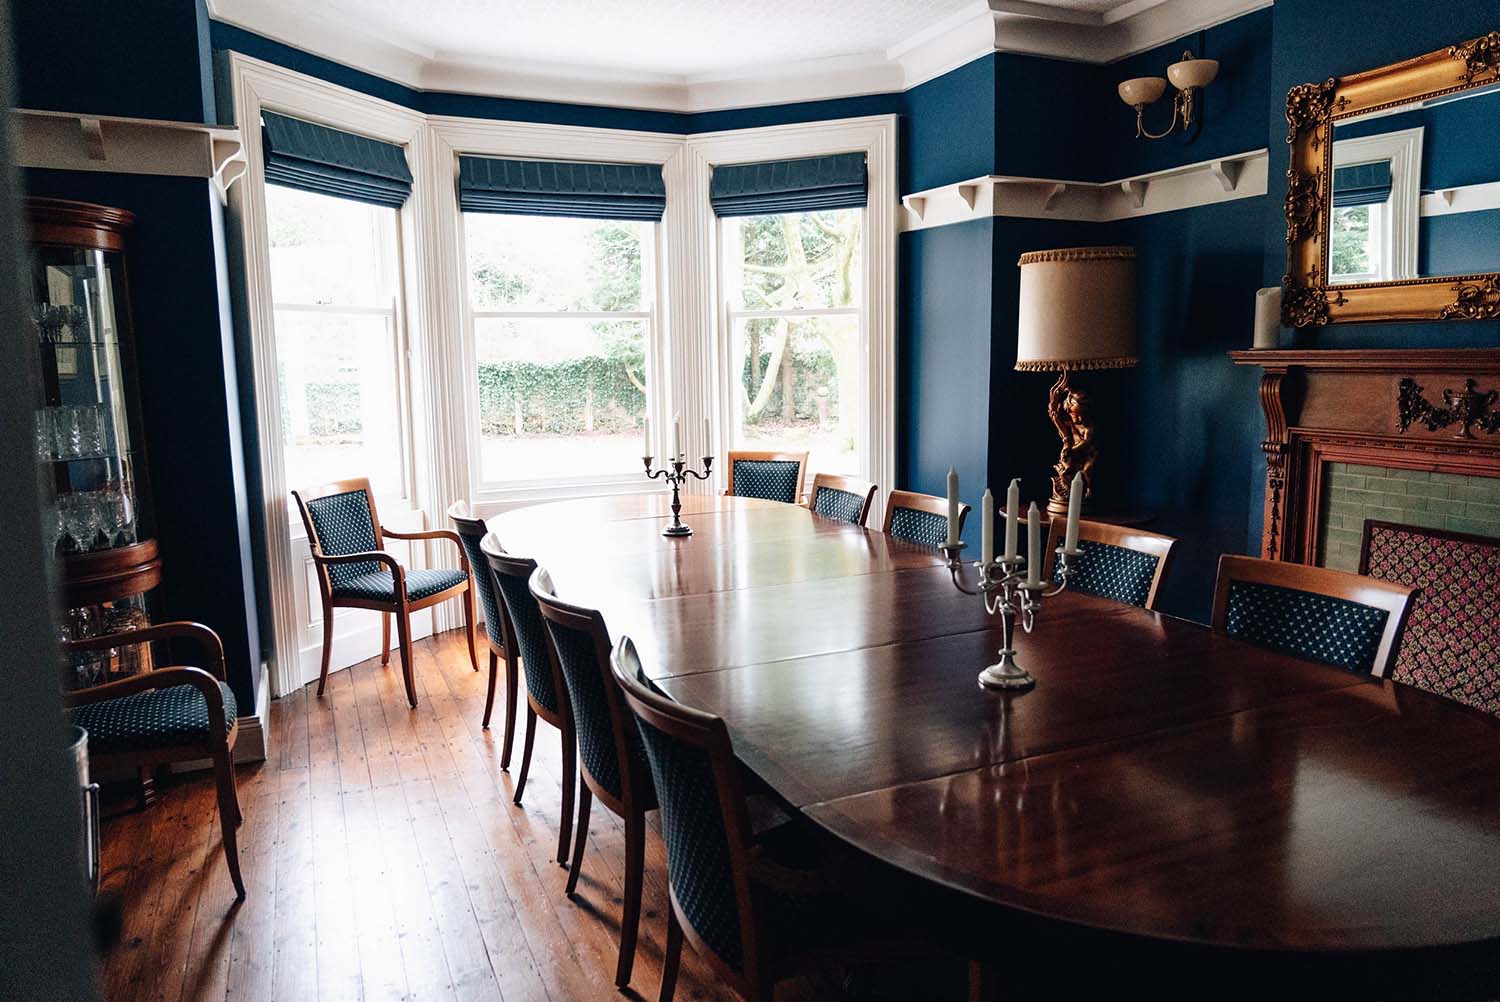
top-left (459, 156), bottom-right (666, 222)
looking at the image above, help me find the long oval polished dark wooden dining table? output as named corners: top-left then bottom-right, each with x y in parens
top-left (491, 494), bottom-right (1500, 999)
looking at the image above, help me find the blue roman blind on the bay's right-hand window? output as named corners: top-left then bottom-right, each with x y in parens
top-left (708, 153), bottom-right (870, 216)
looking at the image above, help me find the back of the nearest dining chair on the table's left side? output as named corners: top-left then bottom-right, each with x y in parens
top-left (611, 636), bottom-right (770, 998)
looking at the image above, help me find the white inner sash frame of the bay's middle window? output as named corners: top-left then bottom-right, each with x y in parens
top-left (459, 212), bottom-right (666, 501)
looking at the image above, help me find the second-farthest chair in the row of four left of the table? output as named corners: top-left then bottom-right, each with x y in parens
top-left (480, 534), bottom-right (578, 866)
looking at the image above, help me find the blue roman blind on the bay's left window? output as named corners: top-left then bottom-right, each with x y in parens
top-left (261, 111), bottom-right (411, 209)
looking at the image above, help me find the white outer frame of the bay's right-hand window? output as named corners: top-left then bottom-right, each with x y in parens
top-left (687, 116), bottom-right (900, 525)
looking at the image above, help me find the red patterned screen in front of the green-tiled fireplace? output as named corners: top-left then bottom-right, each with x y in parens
top-left (1359, 519), bottom-right (1500, 716)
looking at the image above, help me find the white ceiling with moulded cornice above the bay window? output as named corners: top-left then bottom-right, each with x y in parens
top-left (209, 0), bottom-right (1272, 111)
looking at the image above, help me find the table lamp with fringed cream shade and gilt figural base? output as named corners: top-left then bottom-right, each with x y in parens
top-left (1016, 248), bottom-right (1136, 515)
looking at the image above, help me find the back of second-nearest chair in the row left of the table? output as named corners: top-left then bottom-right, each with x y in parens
top-left (530, 567), bottom-right (653, 816)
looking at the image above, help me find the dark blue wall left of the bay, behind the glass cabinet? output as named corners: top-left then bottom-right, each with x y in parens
top-left (15, 0), bottom-right (261, 713)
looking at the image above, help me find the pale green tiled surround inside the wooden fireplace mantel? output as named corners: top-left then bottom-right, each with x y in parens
top-left (1317, 462), bottom-right (1500, 572)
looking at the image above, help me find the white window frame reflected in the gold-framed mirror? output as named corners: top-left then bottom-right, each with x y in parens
top-left (1323, 126), bottom-right (1424, 285)
